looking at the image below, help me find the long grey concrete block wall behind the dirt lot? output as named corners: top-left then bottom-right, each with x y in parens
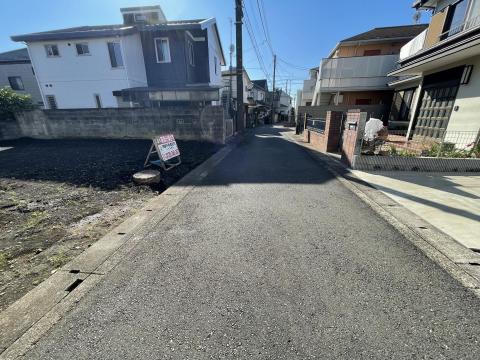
top-left (0, 106), bottom-right (226, 144)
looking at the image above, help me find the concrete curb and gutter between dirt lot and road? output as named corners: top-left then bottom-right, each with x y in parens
top-left (0, 137), bottom-right (243, 359)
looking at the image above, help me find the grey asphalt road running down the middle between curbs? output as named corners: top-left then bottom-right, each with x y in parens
top-left (26, 128), bottom-right (480, 359)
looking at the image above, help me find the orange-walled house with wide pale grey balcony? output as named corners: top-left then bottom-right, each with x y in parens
top-left (310, 25), bottom-right (427, 120)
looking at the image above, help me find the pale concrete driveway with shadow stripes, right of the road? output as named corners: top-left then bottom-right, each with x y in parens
top-left (352, 170), bottom-right (480, 250)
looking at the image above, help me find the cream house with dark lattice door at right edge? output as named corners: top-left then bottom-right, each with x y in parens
top-left (389, 0), bottom-right (480, 138)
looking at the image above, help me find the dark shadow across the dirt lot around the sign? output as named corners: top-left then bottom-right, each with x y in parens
top-left (0, 138), bottom-right (219, 190)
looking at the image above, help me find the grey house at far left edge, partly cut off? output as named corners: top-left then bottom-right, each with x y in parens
top-left (0, 48), bottom-right (43, 106)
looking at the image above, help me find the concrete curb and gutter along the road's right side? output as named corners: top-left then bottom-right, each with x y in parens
top-left (285, 134), bottom-right (480, 298)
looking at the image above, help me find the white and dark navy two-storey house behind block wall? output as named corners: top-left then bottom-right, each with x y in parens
top-left (12, 6), bottom-right (225, 108)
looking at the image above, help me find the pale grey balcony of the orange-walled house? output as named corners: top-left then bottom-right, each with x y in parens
top-left (316, 55), bottom-right (399, 92)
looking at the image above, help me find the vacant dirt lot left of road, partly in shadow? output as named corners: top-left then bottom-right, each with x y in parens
top-left (0, 139), bottom-right (218, 311)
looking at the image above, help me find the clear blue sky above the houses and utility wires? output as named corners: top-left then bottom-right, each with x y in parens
top-left (0, 0), bottom-right (428, 95)
